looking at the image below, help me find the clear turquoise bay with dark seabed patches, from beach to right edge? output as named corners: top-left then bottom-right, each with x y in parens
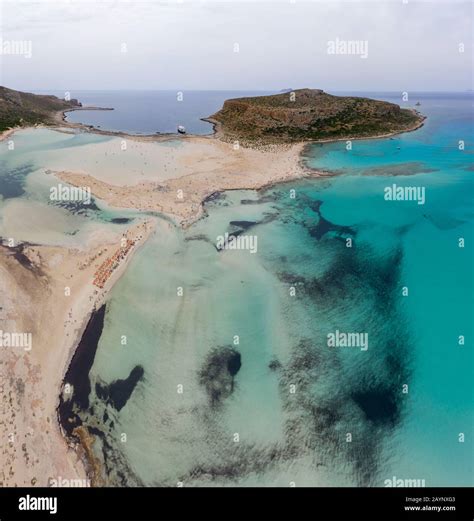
top-left (0, 91), bottom-right (474, 486)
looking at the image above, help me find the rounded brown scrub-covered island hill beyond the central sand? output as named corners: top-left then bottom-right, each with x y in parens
top-left (207, 89), bottom-right (424, 143)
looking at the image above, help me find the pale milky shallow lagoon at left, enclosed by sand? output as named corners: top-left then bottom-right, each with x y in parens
top-left (0, 129), bottom-right (159, 249)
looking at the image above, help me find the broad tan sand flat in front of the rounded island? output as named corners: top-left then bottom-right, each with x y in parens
top-left (54, 136), bottom-right (314, 227)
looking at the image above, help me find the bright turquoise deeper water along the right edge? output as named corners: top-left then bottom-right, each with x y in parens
top-left (298, 92), bottom-right (474, 486)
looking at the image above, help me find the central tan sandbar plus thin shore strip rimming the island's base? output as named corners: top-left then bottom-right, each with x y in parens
top-left (48, 102), bottom-right (426, 227)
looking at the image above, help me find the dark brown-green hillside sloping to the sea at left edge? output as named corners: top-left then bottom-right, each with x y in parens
top-left (0, 86), bottom-right (81, 131)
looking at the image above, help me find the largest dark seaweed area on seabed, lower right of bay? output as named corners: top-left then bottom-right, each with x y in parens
top-left (178, 209), bottom-right (410, 486)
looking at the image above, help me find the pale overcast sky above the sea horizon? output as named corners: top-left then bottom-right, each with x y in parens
top-left (0, 0), bottom-right (474, 91)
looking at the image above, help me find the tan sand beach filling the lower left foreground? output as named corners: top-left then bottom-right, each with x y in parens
top-left (0, 219), bottom-right (154, 486)
